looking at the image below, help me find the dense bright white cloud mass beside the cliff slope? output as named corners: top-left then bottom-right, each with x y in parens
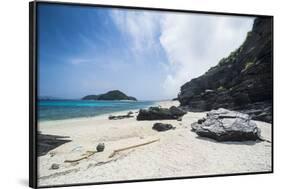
top-left (160, 13), bottom-right (253, 97)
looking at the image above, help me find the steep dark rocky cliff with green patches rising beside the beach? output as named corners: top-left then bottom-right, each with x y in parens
top-left (178, 17), bottom-right (273, 122)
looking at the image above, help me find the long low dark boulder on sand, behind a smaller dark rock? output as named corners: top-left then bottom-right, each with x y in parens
top-left (137, 106), bottom-right (186, 120)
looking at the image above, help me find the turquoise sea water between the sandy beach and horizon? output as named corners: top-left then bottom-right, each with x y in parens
top-left (38, 100), bottom-right (154, 121)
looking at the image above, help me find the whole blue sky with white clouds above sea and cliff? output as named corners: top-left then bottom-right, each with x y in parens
top-left (38, 4), bottom-right (253, 100)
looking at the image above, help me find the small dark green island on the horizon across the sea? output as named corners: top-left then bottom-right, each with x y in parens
top-left (82, 90), bottom-right (137, 101)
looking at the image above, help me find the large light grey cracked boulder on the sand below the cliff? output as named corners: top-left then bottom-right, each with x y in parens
top-left (191, 108), bottom-right (260, 141)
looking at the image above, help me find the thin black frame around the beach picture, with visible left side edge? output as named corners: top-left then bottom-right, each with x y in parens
top-left (29, 0), bottom-right (274, 188)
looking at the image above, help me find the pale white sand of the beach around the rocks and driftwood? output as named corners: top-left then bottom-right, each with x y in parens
top-left (38, 101), bottom-right (272, 186)
